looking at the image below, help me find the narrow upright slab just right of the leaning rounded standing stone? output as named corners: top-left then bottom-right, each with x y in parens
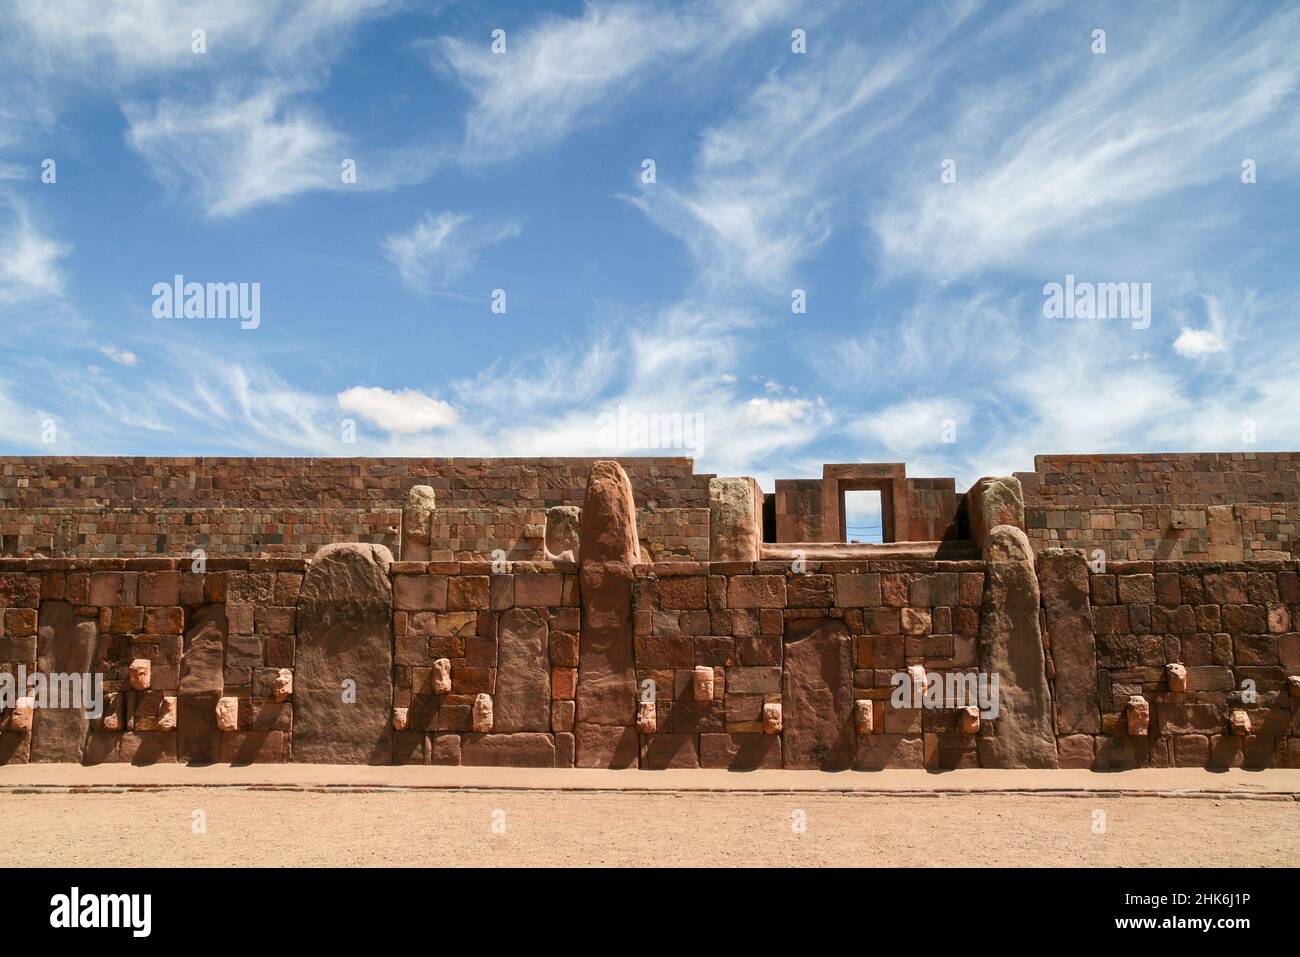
top-left (1037, 549), bottom-right (1101, 735)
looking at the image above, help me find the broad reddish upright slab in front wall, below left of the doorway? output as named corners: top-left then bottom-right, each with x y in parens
top-left (780, 619), bottom-right (855, 771)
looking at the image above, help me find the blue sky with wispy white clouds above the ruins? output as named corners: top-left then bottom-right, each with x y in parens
top-left (0, 0), bottom-right (1300, 488)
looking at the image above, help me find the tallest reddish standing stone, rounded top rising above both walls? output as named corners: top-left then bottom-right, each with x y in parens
top-left (576, 460), bottom-right (641, 767)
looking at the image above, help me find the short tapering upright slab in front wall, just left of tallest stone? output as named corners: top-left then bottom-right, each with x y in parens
top-left (493, 609), bottom-right (551, 732)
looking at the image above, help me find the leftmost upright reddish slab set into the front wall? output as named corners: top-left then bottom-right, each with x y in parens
top-left (30, 601), bottom-right (99, 763)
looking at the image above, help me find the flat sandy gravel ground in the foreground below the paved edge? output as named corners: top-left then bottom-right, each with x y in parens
top-left (0, 788), bottom-right (1300, 867)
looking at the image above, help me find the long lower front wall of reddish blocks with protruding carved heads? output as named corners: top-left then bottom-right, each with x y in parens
top-left (0, 546), bottom-right (1300, 770)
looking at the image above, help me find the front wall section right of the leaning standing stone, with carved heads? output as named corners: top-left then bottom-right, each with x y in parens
top-left (1040, 558), bottom-right (1300, 770)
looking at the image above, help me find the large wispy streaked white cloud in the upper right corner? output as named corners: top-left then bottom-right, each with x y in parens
top-left (871, 16), bottom-right (1300, 280)
